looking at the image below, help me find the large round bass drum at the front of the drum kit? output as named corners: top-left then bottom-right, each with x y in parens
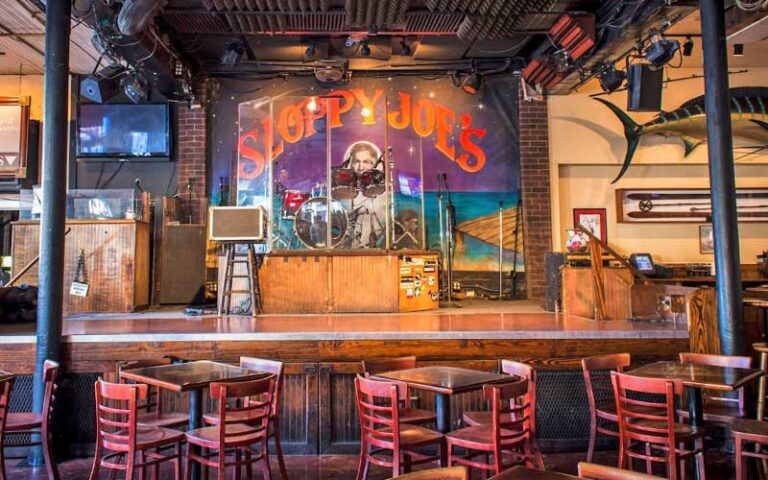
top-left (293, 197), bottom-right (349, 249)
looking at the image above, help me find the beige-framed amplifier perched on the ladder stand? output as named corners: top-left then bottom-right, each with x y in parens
top-left (208, 207), bottom-right (267, 242)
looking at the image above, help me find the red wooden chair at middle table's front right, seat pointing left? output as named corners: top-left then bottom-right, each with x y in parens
top-left (445, 379), bottom-right (534, 475)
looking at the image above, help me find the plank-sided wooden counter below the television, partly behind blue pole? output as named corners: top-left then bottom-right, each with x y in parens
top-left (11, 219), bottom-right (149, 315)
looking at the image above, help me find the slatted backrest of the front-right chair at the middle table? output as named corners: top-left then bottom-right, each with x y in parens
top-left (483, 379), bottom-right (531, 456)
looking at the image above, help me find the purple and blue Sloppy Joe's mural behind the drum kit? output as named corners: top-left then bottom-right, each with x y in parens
top-left (212, 77), bottom-right (523, 271)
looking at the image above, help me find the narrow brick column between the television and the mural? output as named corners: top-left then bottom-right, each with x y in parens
top-left (176, 81), bottom-right (209, 223)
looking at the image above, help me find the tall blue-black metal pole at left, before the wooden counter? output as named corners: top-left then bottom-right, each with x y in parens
top-left (29, 0), bottom-right (72, 465)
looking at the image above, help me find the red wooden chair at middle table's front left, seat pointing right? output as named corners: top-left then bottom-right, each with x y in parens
top-left (355, 376), bottom-right (445, 480)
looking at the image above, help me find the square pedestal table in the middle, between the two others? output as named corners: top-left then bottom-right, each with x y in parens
top-left (375, 366), bottom-right (514, 433)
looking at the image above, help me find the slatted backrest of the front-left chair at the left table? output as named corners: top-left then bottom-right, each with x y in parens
top-left (95, 379), bottom-right (147, 450)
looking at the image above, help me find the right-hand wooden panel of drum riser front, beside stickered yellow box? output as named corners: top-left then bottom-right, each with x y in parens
top-left (331, 255), bottom-right (399, 313)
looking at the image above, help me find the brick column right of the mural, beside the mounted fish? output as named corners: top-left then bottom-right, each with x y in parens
top-left (519, 95), bottom-right (552, 300)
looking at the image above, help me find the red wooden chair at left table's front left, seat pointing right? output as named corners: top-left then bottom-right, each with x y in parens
top-left (89, 379), bottom-right (184, 480)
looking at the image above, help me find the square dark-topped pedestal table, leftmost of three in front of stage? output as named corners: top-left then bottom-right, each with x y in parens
top-left (120, 360), bottom-right (271, 480)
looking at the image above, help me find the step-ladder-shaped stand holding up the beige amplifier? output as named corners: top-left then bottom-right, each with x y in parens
top-left (218, 242), bottom-right (264, 317)
